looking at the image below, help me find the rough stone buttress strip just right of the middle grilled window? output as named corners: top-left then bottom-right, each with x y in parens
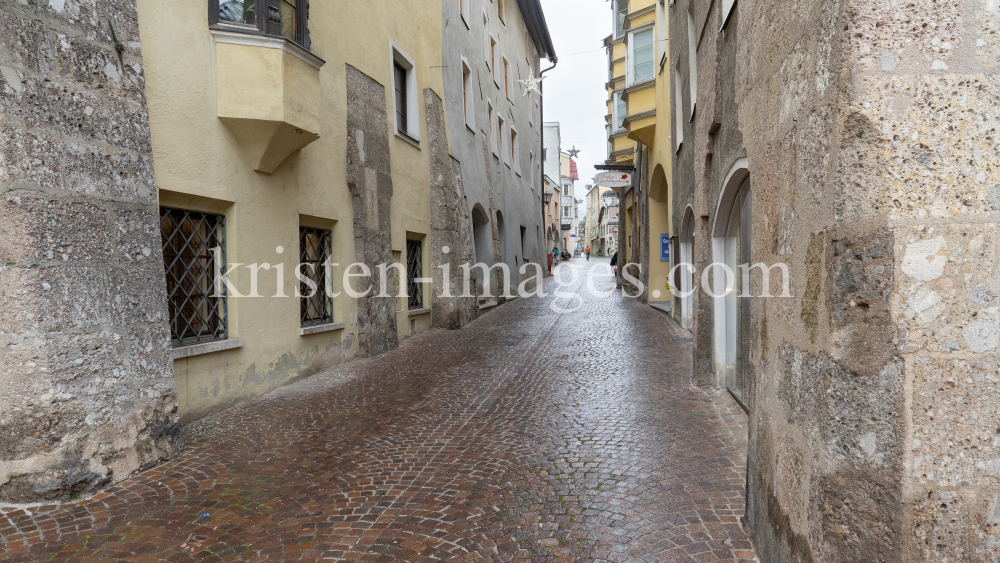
top-left (347, 65), bottom-right (399, 356)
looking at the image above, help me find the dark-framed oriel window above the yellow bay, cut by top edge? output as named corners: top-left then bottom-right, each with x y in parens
top-left (214, 0), bottom-right (312, 50)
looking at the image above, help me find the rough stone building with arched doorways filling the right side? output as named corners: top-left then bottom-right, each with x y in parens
top-left (668, 0), bottom-right (1000, 562)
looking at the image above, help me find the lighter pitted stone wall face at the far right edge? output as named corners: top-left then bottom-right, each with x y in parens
top-left (834, 0), bottom-right (1000, 561)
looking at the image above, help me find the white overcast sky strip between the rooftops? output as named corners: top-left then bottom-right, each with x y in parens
top-left (542, 0), bottom-right (612, 219)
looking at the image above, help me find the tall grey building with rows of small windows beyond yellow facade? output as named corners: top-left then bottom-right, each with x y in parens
top-left (443, 0), bottom-right (558, 295)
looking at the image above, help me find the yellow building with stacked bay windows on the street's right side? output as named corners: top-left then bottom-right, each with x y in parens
top-left (605, 0), bottom-right (675, 303)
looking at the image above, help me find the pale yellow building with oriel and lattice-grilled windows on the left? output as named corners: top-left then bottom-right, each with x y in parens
top-left (138, 0), bottom-right (456, 422)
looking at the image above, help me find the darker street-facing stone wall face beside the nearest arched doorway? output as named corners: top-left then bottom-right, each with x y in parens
top-left (732, 0), bottom-right (908, 561)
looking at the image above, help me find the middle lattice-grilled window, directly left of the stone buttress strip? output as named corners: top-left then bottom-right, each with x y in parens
top-left (299, 227), bottom-right (333, 327)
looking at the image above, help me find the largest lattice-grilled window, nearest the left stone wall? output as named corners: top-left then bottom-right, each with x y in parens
top-left (160, 207), bottom-right (229, 348)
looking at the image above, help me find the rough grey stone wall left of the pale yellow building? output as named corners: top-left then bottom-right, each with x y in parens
top-left (0, 0), bottom-right (179, 502)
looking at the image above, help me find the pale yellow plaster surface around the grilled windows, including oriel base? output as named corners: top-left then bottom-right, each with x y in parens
top-left (138, 0), bottom-right (447, 422)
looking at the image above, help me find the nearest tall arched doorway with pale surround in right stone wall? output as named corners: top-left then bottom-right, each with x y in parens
top-left (712, 159), bottom-right (753, 410)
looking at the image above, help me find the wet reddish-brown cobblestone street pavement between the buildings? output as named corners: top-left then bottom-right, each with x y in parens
top-left (0, 260), bottom-right (754, 563)
